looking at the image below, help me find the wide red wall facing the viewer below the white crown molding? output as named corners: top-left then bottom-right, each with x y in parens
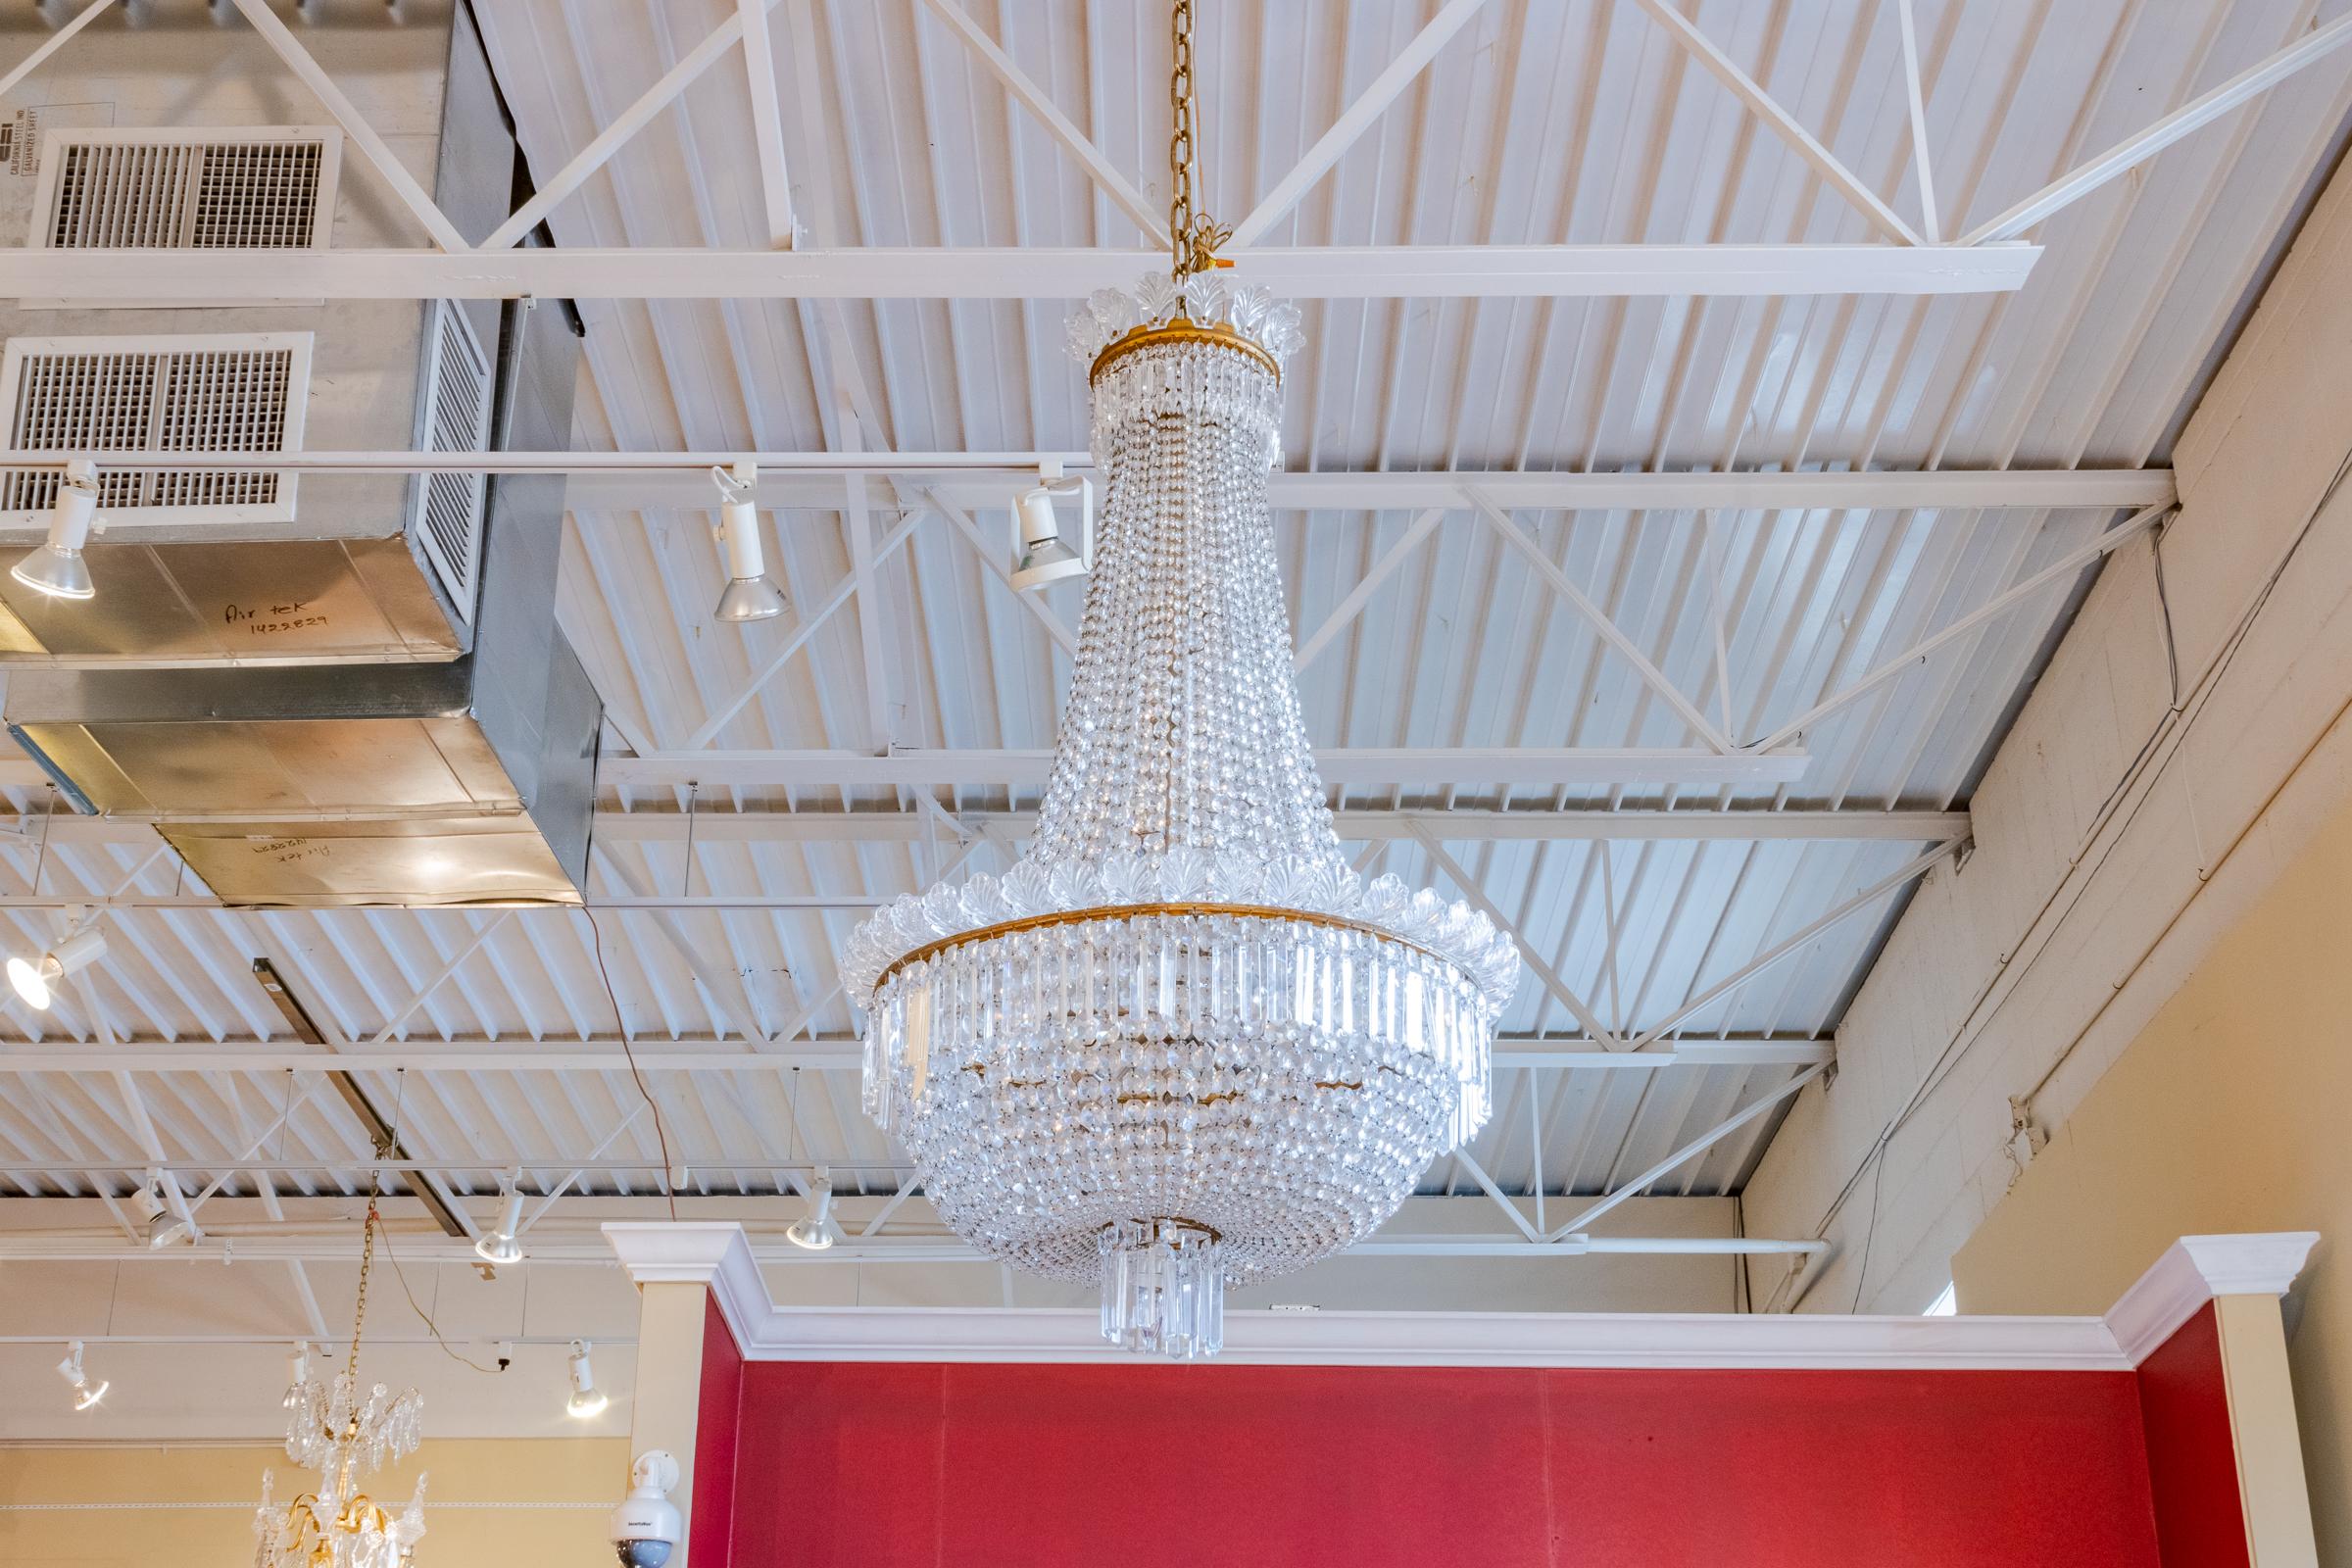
top-left (724, 1361), bottom-right (2154, 1568)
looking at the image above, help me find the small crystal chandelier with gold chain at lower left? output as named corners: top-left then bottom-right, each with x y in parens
top-left (254, 1197), bottom-right (425, 1568)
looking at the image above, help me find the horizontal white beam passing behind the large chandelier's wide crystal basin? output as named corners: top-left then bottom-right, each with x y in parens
top-left (0, 1034), bottom-right (1835, 1071)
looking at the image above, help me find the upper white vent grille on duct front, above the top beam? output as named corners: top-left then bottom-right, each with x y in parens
top-left (30, 127), bottom-right (343, 249)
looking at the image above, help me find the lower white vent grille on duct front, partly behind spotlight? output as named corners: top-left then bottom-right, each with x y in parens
top-left (0, 331), bottom-right (311, 522)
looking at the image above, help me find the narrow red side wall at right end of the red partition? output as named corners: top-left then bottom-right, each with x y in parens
top-left (2140, 1304), bottom-right (2246, 1568)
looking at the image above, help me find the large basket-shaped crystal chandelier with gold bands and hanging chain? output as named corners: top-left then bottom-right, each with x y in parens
top-left (845, 0), bottom-right (1519, 1359)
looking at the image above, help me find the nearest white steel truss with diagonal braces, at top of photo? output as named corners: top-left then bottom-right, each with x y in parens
top-left (0, 0), bottom-right (2352, 303)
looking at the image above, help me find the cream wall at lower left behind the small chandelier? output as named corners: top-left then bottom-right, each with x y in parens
top-left (0, 1439), bottom-right (628, 1568)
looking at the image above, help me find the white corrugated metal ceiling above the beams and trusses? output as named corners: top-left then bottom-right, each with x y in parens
top-left (0, 0), bottom-right (2352, 1222)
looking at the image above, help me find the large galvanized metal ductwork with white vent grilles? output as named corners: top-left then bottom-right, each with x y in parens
top-left (0, 0), bottom-right (602, 906)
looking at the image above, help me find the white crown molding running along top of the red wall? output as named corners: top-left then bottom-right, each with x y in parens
top-left (605, 1222), bottom-right (2319, 1373)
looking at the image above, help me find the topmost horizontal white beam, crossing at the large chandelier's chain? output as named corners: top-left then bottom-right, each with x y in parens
top-left (0, 240), bottom-right (2041, 306)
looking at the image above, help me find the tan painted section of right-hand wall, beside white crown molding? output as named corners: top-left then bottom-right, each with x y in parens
top-left (1952, 780), bottom-right (2352, 1563)
